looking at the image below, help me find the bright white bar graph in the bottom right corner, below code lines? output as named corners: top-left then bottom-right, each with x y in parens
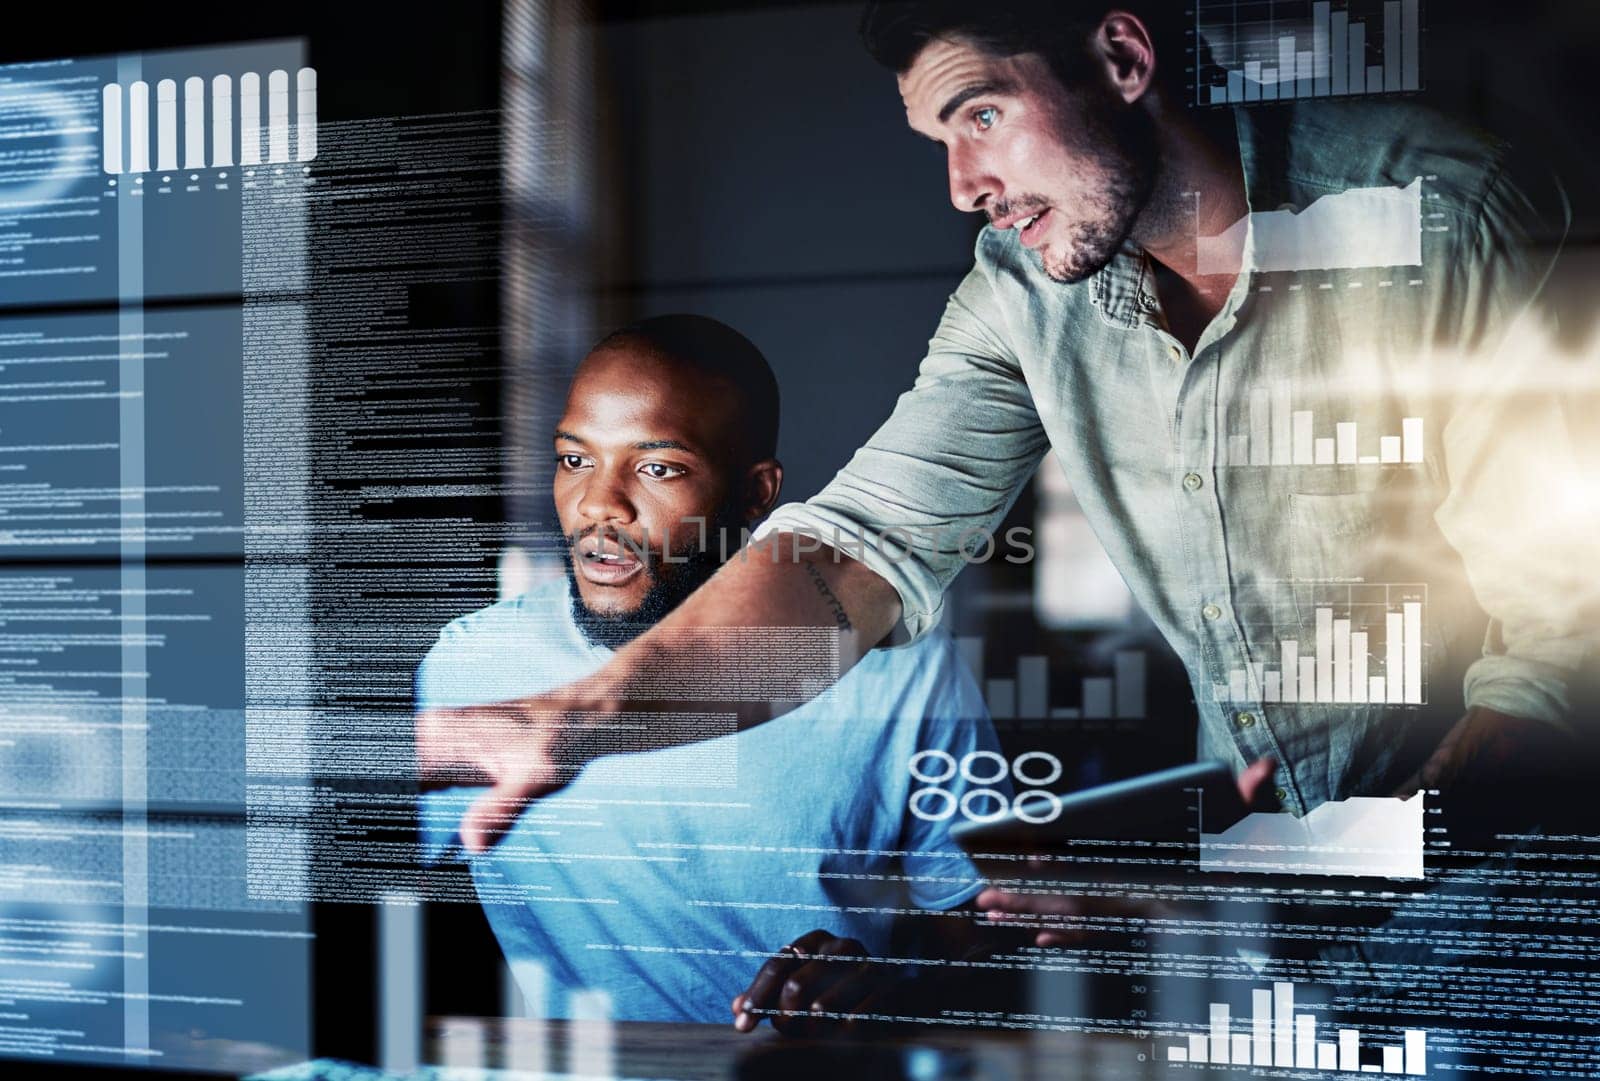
top-left (1165, 983), bottom-right (1427, 1078)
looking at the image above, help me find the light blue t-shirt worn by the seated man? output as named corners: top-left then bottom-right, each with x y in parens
top-left (418, 580), bottom-right (1010, 1023)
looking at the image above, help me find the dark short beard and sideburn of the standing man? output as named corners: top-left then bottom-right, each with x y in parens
top-left (1040, 88), bottom-right (1157, 285)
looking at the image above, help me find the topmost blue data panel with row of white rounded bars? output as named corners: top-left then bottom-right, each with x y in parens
top-left (0, 40), bottom-right (317, 307)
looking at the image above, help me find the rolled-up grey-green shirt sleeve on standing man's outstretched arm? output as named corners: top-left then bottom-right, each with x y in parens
top-left (757, 255), bottom-right (1048, 641)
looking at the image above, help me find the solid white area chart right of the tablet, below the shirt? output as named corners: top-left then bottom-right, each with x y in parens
top-left (1200, 792), bottom-right (1426, 880)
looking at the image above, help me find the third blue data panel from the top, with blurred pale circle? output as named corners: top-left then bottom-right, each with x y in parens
top-left (0, 564), bottom-right (246, 812)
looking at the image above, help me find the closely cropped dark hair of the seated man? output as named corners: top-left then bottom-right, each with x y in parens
top-left (589, 313), bottom-right (779, 462)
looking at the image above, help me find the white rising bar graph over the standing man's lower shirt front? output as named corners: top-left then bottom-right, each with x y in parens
top-left (1211, 582), bottom-right (1427, 705)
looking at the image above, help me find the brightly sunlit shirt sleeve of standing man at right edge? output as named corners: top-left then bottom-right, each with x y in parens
top-left (1435, 155), bottom-right (1600, 724)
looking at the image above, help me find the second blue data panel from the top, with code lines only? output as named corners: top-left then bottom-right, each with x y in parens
top-left (0, 305), bottom-right (243, 558)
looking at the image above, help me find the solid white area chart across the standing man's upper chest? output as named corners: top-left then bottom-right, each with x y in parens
top-left (1195, 178), bottom-right (1422, 273)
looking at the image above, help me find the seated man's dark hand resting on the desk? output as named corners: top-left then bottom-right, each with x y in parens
top-left (733, 929), bottom-right (906, 1036)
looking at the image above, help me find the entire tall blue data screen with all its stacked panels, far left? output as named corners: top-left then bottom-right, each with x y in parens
top-left (0, 33), bottom-right (317, 1076)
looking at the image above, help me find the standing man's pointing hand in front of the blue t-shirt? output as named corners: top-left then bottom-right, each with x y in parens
top-left (416, 697), bottom-right (587, 852)
